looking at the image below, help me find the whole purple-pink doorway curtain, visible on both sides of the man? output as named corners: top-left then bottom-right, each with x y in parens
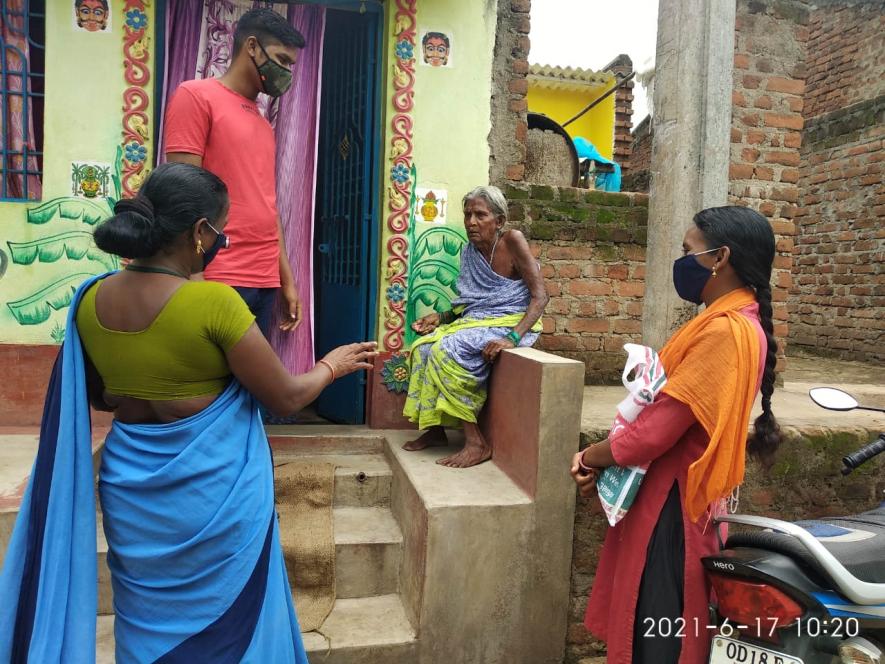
top-left (159, 0), bottom-right (326, 373)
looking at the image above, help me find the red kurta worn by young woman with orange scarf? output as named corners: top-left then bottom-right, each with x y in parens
top-left (584, 305), bottom-right (767, 664)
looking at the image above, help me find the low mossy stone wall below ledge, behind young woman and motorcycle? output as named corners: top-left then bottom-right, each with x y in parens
top-left (564, 430), bottom-right (885, 664)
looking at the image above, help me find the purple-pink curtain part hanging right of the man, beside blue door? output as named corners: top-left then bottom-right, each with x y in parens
top-left (271, 5), bottom-right (326, 373)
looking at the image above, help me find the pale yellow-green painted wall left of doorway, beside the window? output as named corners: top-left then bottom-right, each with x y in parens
top-left (0, 0), bottom-right (154, 344)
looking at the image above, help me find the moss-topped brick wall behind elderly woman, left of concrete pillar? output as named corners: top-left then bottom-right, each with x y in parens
top-left (506, 185), bottom-right (648, 383)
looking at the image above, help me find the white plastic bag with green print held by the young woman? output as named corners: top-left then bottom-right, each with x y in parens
top-left (596, 344), bottom-right (667, 526)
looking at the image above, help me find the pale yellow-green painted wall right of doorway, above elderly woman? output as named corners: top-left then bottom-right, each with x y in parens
top-left (378, 0), bottom-right (497, 350)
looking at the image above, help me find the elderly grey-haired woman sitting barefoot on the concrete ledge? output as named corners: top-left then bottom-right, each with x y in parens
top-left (403, 187), bottom-right (549, 468)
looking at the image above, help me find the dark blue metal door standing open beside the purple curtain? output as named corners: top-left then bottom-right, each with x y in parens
top-left (314, 9), bottom-right (378, 424)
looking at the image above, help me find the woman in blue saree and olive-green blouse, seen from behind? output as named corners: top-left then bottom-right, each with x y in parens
top-left (0, 164), bottom-right (375, 664)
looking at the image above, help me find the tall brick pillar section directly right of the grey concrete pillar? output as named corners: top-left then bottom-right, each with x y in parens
top-left (728, 0), bottom-right (808, 368)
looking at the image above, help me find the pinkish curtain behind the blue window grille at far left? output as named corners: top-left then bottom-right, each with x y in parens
top-left (0, 0), bottom-right (42, 200)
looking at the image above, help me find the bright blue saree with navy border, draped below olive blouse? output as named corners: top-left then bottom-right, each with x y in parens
top-left (0, 280), bottom-right (307, 664)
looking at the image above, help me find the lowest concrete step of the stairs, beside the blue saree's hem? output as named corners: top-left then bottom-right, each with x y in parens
top-left (95, 595), bottom-right (418, 664)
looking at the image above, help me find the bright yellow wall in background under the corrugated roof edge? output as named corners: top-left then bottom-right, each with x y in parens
top-left (527, 81), bottom-right (615, 159)
